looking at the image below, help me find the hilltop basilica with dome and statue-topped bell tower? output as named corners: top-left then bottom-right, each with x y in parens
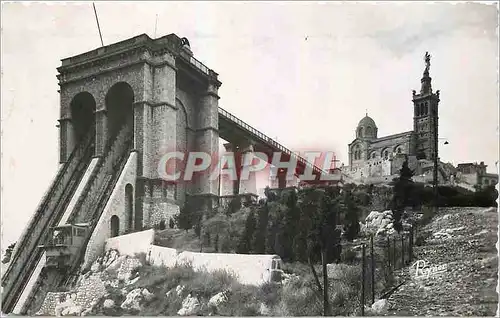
top-left (344, 53), bottom-right (439, 181)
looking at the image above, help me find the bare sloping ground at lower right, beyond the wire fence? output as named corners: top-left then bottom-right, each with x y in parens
top-left (389, 208), bottom-right (498, 316)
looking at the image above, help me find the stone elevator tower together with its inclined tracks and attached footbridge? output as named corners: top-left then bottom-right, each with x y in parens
top-left (2, 34), bottom-right (328, 315)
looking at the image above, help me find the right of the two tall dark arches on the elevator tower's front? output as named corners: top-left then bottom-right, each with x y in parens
top-left (105, 82), bottom-right (134, 139)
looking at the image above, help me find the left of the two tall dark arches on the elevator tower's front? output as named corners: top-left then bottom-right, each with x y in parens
top-left (70, 92), bottom-right (96, 143)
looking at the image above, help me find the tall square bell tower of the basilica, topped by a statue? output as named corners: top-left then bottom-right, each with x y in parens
top-left (413, 52), bottom-right (439, 160)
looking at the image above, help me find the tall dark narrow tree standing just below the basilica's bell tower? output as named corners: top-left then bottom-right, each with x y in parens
top-left (392, 156), bottom-right (413, 232)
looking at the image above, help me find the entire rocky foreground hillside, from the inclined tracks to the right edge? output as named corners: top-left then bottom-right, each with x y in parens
top-left (17, 208), bottom-right (498, 316)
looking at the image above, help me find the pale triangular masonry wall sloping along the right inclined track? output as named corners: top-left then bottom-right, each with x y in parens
top-left (83, 152), bottom-right (137, 268)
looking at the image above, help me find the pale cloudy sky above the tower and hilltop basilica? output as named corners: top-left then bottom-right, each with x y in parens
top-left (1, 1), bottom-right (498, 248)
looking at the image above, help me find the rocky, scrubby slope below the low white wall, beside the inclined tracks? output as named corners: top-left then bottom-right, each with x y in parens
top-left (36, 250), bottom-right (312, 316)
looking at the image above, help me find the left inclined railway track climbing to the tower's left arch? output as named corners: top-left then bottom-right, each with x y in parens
top-left (2, 132), bottom-right (95, 312)
